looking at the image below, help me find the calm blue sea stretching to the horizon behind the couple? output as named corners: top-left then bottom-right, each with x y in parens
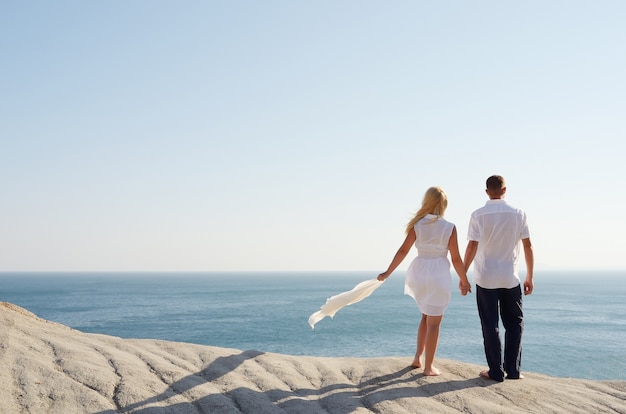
top-left (0, 271), bottom-right (626, 380)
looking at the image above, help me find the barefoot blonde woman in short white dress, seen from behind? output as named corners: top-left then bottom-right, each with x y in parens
top-left (378, 187), bottom-right (472, 376)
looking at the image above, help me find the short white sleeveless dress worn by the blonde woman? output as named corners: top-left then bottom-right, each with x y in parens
top-left (404, 214), bottom-right (454, 316)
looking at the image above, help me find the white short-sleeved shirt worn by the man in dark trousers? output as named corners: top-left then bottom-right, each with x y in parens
top-left (467, 199), bottom-right (530, 289)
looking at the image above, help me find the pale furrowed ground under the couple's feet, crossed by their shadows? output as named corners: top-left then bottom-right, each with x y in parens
top-left (0, 302), bottom-right (626, 414)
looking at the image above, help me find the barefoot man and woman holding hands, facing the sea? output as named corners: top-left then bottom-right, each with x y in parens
top-left (378, 175), bottom-right (534, 381)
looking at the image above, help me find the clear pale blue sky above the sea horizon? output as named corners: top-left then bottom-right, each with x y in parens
top-left (0, 0), bottom-right (626, 272)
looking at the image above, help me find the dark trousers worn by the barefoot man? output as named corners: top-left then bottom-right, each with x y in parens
top-left (476, 285), bottom-right (524, 381)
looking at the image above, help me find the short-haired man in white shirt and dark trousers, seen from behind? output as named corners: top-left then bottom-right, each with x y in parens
top-left (463, 175), bottom-right (534, 381)
